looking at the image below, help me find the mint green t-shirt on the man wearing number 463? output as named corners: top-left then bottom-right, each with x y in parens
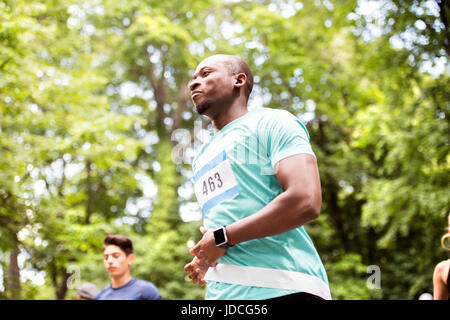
top-left (192, 108), bottom-right (328, 299)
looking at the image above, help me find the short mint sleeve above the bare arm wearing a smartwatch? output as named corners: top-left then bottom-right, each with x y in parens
top-left (266, 111), bottom-right (316, 167)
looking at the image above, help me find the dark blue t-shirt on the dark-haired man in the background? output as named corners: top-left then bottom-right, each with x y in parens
top-left (95, 278), bottom-right (161, 300)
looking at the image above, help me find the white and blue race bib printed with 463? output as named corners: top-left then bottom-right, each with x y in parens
top-left (194, 151), bottom-right (239, 217)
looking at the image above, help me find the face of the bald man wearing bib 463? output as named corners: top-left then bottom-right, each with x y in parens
top-left (189, 56), bottom-right (234, 118)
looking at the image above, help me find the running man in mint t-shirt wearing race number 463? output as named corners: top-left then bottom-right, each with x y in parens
top-left (185, 55), bottom-right (331, 300)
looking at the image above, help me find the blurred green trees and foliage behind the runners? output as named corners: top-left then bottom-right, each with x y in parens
top-left (0, 0), bottom-right (450, 299)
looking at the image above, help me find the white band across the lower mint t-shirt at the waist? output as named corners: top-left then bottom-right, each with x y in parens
top-left (205, 264), bottom-right (331, 300)
